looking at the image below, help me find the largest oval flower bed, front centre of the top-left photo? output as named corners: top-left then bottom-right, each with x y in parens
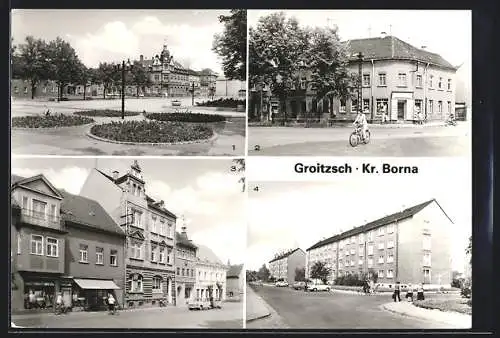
top-left (90, 121), bottom-right (214, 143)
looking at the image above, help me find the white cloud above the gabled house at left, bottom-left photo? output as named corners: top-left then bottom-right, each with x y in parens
top-left (12, 167), bottom-right (89, 194)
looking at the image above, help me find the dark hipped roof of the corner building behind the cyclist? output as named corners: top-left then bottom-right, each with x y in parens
top-left (345, 36), bottom-right (456, 70)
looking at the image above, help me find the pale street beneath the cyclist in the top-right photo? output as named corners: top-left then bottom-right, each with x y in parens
top-left (248, 122), bottom-right (471, 157)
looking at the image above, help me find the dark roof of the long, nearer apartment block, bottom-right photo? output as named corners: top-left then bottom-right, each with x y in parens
top-left (306, 199), bottom-right (453, 251)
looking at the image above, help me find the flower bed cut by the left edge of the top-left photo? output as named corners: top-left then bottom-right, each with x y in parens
top-left (12, 114), bottom-right (94, 128)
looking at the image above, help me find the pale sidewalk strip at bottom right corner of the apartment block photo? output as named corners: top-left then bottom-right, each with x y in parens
top-left (382, 302), bottom-right (472, 329)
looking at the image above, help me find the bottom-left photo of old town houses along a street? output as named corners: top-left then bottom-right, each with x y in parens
top-left (10, 158), bottom-right (246, 329)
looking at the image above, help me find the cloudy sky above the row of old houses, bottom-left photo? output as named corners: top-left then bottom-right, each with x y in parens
top-left (12, 157), bottom-right (246, 264)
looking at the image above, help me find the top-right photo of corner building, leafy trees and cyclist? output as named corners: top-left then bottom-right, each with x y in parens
top-left (248, 10), bottom-right (472, 157)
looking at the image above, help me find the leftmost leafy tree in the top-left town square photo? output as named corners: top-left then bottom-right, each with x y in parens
top-left (16, 36), bottom-right (50, 99)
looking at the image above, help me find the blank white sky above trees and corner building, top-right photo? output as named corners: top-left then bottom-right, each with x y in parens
top-left (248, 10), bottom-right (472, 66)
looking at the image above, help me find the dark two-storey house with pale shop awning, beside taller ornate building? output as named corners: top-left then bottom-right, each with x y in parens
top-left (60, 190), bottom-right (125, 309)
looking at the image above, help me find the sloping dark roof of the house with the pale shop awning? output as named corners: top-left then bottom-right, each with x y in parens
top-left (61, 190), bottom-right (125, 236)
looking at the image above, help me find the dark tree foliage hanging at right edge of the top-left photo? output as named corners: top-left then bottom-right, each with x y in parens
top-left (212, 9), bottom-right (247, 81)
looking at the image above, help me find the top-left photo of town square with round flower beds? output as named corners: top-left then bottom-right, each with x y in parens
top-left (10, 9), bottom-right (247, 156)
